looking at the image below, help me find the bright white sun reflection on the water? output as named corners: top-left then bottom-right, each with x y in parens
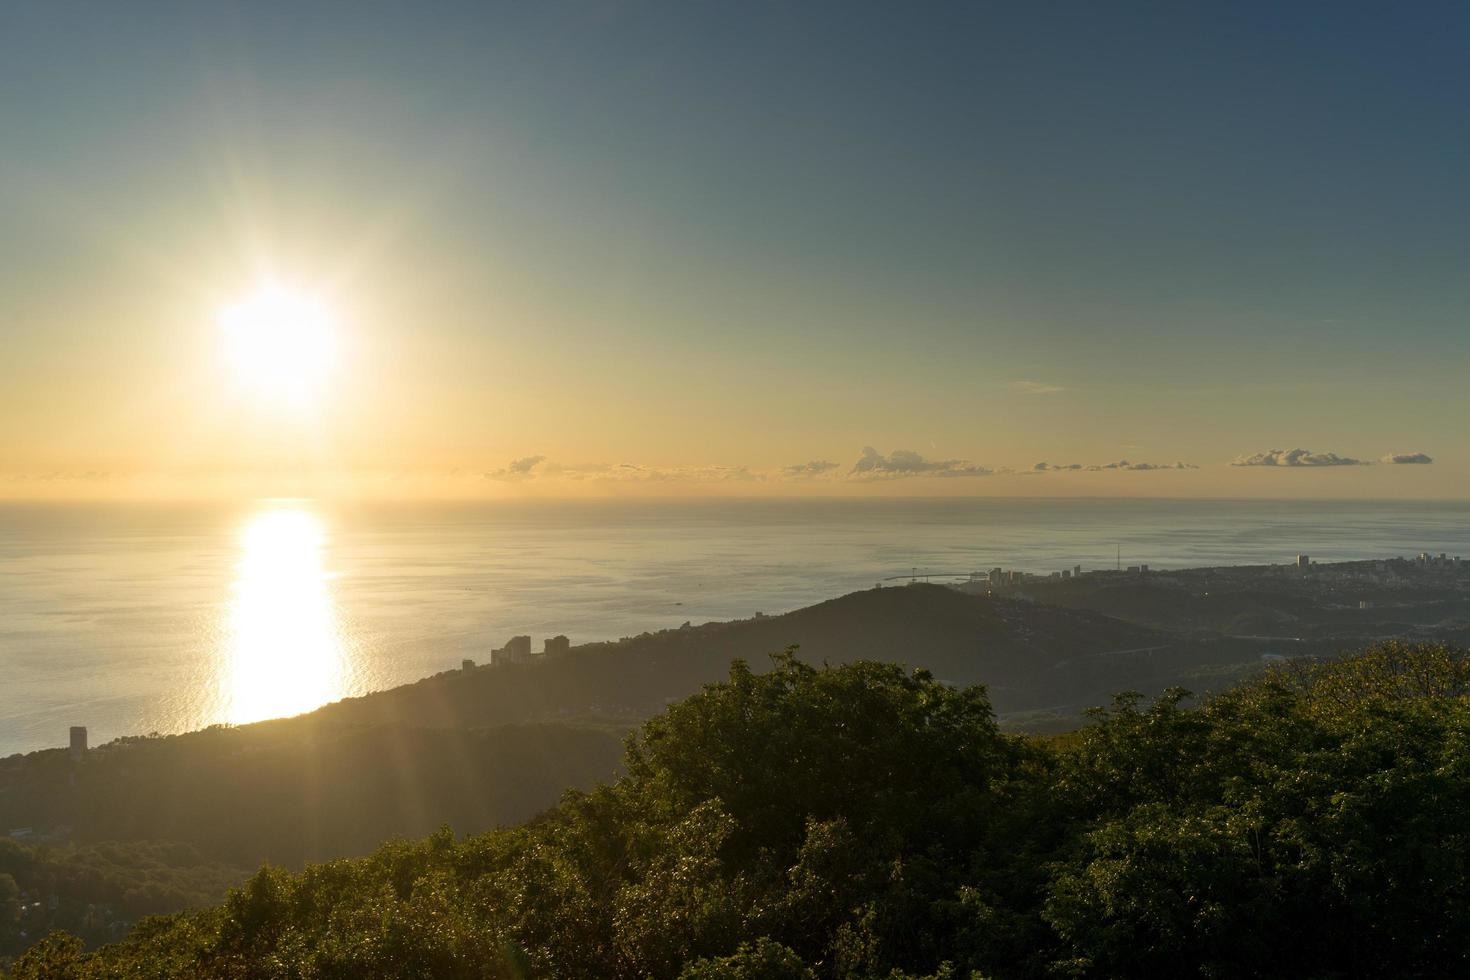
top-left (221, 505), bottom-right (347, 724)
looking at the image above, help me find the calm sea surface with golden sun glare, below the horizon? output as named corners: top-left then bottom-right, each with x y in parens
top-left (0, 500), bottom-right (1470, 755)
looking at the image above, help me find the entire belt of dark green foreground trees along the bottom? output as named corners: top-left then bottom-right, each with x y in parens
top-left (12, 645), bottom-right (1470, 980)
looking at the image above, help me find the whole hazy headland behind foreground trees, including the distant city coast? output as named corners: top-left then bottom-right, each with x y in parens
top-left (11, 554), bottom-right (1470, 864)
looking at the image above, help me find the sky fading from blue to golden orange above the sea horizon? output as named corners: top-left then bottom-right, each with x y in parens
top-left (0, 0), bottom-right (1470, 498)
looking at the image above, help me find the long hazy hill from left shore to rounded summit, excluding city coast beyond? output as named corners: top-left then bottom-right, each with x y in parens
top-left (0, 585), bottom-right (1264, 867)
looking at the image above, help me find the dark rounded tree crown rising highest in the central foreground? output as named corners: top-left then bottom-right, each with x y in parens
top-left (628, 652), bottom-right (1008, 858)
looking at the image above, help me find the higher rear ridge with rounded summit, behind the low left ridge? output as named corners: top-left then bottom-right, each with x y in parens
top-left (320, 585), bottom-right (1228, 726)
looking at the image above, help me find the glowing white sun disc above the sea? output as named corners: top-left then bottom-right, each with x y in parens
top-left (216, 284), bottom-right (337, 408)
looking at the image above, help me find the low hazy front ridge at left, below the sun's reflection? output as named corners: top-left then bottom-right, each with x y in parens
top-left (0, 714), bottom-right (620, 869)
